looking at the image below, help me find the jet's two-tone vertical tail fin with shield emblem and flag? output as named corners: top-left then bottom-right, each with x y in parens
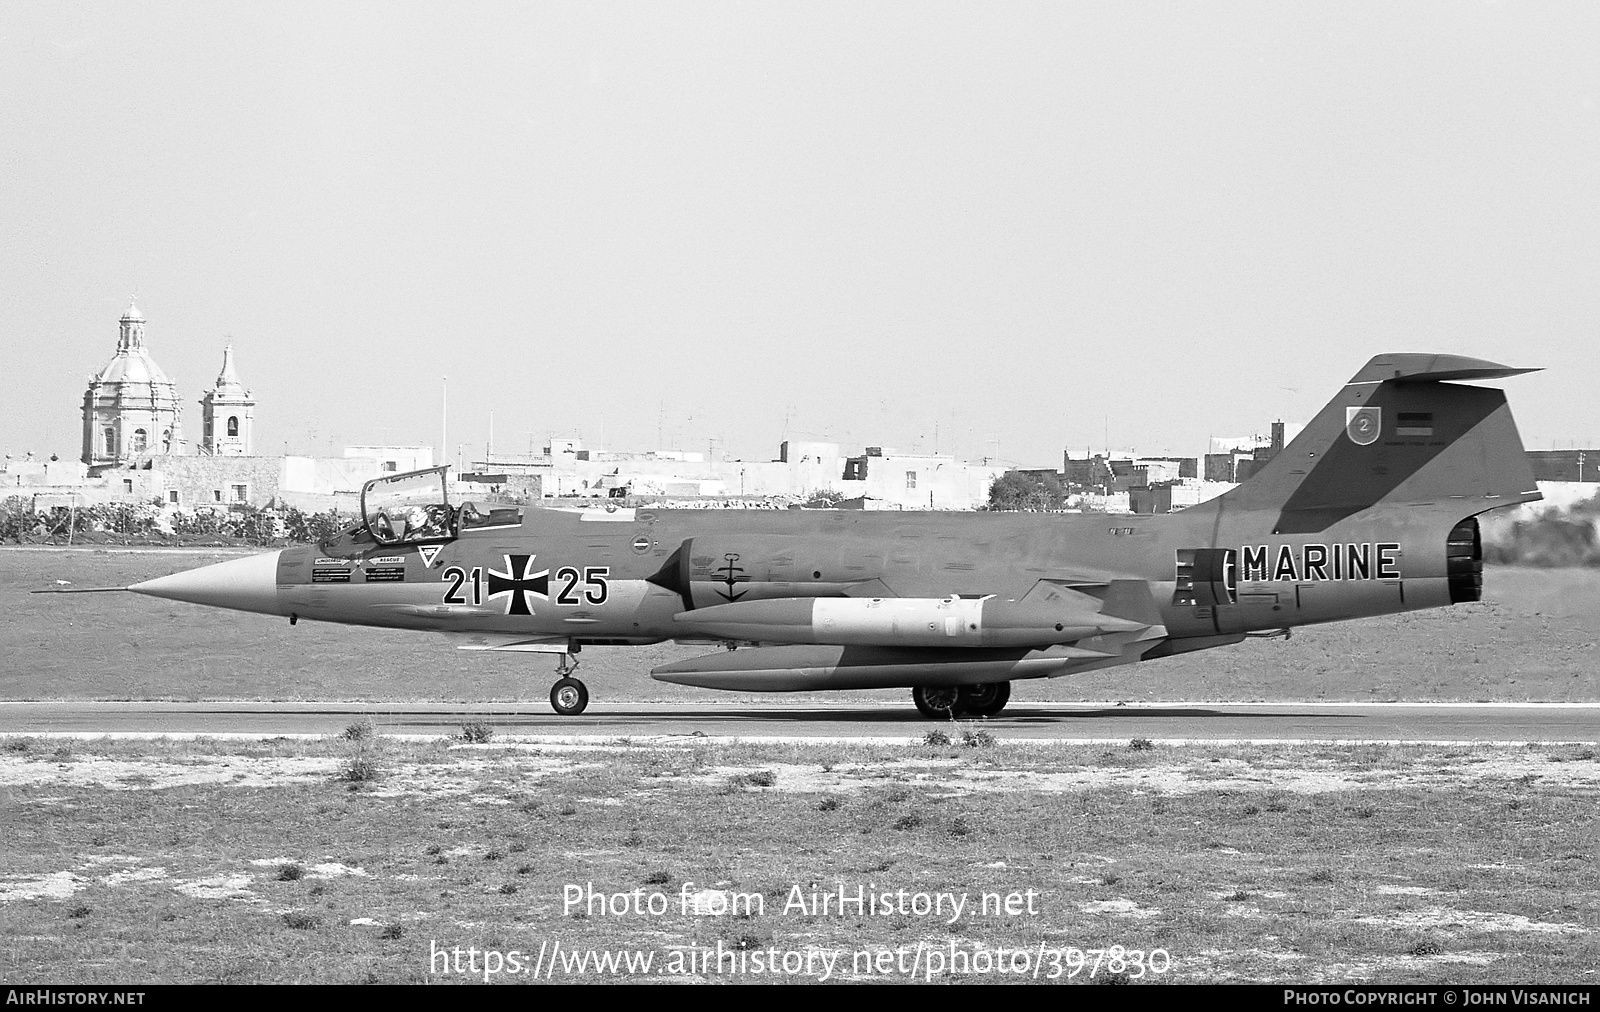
top-left (1216, 354), bottom-right (1539, 533)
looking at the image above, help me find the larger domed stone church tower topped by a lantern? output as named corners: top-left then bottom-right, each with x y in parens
top-left (82, 304), bottom-right (187, 468)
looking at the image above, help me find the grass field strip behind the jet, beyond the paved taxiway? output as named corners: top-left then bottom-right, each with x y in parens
top-left (0, 548), bottom-right (1600, 701)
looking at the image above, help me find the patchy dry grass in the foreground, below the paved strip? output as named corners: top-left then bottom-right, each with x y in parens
top-left (0, 738), bottom-right (1600, 983)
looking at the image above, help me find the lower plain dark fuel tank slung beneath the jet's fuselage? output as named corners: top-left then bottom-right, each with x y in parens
top-left (650, 645), bottom-right (1110, 692)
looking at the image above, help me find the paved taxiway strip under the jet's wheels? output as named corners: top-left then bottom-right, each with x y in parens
top-left (0, 700), bottom-right (1600, 741)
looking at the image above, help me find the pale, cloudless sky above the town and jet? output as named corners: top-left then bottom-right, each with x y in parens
top-left (0, 0), bottom-right (1600, 468)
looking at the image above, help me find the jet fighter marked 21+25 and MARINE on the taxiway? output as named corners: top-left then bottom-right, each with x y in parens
top-left (109, 354), bottom-right (1539, 717)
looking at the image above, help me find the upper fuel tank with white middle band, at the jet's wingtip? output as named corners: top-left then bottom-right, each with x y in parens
top-left (674, 597), bottom-right (1146, 647)
